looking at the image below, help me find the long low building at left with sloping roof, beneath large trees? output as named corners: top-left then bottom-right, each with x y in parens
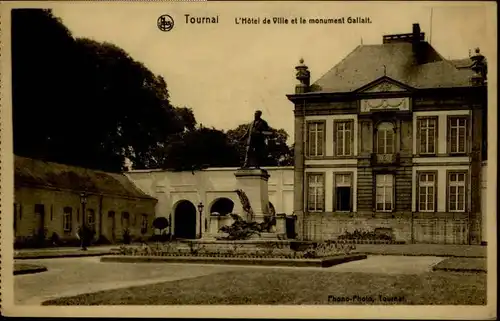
top-left (13, 156), bottom-right (156, 244)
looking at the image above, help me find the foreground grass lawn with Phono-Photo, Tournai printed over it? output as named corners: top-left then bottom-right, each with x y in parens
top-left (43, 269), bottom-right (487, 305)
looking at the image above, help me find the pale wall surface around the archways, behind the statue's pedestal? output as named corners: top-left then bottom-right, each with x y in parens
top-left (126, 167), bottom-right (294, 233)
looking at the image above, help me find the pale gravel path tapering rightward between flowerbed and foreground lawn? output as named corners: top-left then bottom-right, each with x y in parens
top-left (14, 257), bottom-right (236, 305)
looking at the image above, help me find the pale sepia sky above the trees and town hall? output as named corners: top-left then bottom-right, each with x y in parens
top-left (45, 1), bottom-right (496, 141)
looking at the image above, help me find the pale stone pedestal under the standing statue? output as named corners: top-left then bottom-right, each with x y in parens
top-left (234, 168), bottom-right (270, 223)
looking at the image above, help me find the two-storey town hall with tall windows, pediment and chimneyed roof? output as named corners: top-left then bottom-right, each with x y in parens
top-left (288, 24), bottom-right (487, 244)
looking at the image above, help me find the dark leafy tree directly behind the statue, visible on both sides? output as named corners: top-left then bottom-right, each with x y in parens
top-left (227, 124), bottom-right (293, 166)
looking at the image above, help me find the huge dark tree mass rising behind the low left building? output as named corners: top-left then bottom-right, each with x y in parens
top-left (12, 9), bottom-right (190, 171)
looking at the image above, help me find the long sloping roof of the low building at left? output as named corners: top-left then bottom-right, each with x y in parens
top-left (14, 156), bottom-right (155, 200)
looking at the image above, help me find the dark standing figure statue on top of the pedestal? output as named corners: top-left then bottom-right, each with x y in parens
top-left (242, 110), bottom-right (272, 168)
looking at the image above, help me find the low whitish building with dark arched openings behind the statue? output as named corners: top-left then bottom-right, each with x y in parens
top-left (126, 167), bottom-right (294, 239)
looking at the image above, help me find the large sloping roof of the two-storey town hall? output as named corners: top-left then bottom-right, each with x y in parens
top-left (311, 41), bottom-right (473, 94)
